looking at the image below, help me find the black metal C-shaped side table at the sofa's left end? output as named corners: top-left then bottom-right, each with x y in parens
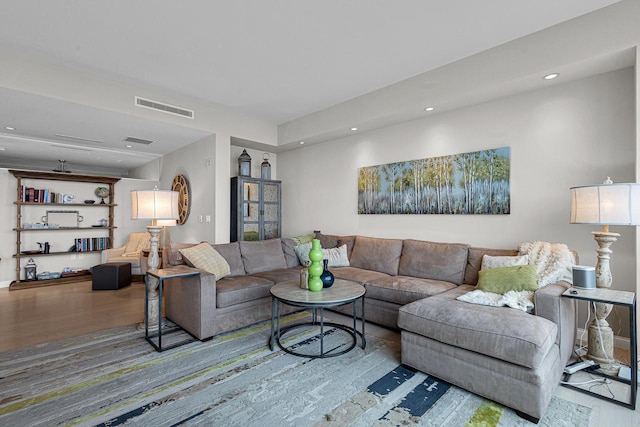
top-left (144, 265), bottom-right (200, 352)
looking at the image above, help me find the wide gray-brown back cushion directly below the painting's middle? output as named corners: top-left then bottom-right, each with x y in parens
top-left (398, 239), bottom-right (469, 285)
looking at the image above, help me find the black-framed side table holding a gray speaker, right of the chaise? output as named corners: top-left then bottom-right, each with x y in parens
top-left (562, 288), bottom-right (638, 410)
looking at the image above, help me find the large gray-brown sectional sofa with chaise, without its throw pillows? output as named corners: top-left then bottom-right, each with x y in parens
top-left (163, 232), bottom-right (576, 422)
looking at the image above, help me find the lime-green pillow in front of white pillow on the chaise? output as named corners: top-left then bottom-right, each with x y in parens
top-left (478, 265), bottom-right (538, 294)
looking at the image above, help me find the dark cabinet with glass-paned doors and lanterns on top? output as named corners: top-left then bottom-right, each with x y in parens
top-left (231, 176), bottom-right (282, 242)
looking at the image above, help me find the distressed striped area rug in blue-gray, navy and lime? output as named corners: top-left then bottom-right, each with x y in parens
top-left (0, 313), bottom-right (590, 427)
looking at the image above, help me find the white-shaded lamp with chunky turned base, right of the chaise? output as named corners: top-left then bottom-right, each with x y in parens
top-left (570, 177), bottom-right (640, 375)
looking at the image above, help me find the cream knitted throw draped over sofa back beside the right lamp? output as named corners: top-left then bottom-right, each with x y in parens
top-left (518, 242), bottom-right (575, 288)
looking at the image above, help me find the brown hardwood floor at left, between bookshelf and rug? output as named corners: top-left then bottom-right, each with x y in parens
top-left (0, 281), bottom-right (144, 352)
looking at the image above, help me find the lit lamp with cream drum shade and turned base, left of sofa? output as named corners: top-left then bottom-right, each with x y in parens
top-left (131, 187), bottom-right (178, 329)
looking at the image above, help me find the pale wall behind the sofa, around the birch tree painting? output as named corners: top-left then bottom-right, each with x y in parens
top-left (278, 68), bottom-right (636, 291)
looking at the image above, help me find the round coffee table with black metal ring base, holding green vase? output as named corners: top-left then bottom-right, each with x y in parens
top-left (269, 279), bottom-right (367, 358)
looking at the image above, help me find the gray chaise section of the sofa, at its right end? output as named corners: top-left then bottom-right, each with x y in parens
top-left (398, 248), bottom-right (576, 422)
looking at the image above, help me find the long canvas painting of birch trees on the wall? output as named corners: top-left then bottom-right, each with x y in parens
top-left (358, 147), bottom-right (511, 215)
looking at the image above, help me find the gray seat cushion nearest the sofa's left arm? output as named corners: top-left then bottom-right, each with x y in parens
top-left (216, 276), bottom-right (274, 308)
